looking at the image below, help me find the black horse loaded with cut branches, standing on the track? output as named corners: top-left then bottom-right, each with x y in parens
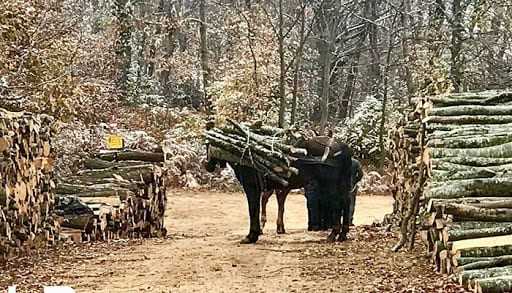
top-left (206, 144), bottom-right (352, 244)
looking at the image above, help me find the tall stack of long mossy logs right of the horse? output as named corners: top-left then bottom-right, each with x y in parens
top-left (391, 91), bottom-right (512, 292)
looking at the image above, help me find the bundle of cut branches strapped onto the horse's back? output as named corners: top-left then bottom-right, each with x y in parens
top-left (206, 120), bottom-right (307, 186)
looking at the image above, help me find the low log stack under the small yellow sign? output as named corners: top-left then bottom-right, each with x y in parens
top-left (56, 151), bottom-right (167, 241)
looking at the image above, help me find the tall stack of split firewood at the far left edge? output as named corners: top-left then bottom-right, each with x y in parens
top-left (0, 109), bottom-right (59, 259)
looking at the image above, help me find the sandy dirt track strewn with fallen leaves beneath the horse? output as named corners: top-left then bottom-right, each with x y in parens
top-left (0, 191), bottom-right (463, 292)
